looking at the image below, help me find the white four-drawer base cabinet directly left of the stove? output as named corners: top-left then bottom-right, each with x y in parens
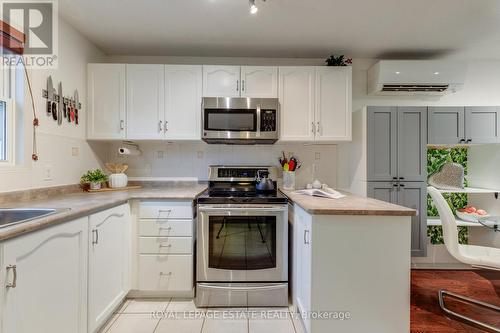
top-left (136, 201), bottom-right (194, 297)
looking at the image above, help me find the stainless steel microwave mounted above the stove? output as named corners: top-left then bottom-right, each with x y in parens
top-left (201, 97), bottom-right (279, 145)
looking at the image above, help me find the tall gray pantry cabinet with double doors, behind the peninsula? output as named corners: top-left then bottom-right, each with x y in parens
top-left (367, 107), bottom-right (427, 256)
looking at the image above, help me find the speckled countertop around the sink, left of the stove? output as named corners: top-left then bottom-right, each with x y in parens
top-left (0, 182), bottom-right (207, 241)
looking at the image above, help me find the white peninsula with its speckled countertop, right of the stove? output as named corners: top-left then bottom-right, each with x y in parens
top-left (282, 190), bottom-right (416, 333)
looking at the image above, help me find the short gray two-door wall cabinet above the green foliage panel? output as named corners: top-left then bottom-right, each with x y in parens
top-left (428, 106), bottom-right (500, 144)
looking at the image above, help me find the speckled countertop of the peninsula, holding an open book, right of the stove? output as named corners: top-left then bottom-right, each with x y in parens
top-left (280, 189), bottom-right (417, 216)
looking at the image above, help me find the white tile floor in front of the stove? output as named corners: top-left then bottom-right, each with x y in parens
top-left (100, 299), bottom-right (302, 333)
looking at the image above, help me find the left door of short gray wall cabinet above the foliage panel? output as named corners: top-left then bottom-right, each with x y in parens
top-left (428, 106), bottom-right (465, 144)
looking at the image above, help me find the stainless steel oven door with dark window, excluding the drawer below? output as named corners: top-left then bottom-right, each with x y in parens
top-left (196, 204), bottom-right (288, 282)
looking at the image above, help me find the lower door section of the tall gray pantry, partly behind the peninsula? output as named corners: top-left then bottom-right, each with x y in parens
top-left (368, 181), bottom-right (427, 257)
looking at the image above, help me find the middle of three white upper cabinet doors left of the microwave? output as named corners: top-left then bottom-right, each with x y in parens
top-left (127, 65), bottom-right (165, 139)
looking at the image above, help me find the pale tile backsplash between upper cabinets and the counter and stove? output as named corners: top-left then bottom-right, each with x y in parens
top-left (102, 142), bottom-right (337, 187)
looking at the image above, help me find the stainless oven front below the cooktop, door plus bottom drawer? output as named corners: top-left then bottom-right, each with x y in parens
top-left (196, 204), bottom-right (288, 306)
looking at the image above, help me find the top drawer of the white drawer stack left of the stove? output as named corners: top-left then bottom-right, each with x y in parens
top-left (139, 201), bottom-right (193, 219)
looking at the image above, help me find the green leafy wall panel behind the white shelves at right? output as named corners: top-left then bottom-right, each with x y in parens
top-left (427, 147), bottom-right (469, 244)
